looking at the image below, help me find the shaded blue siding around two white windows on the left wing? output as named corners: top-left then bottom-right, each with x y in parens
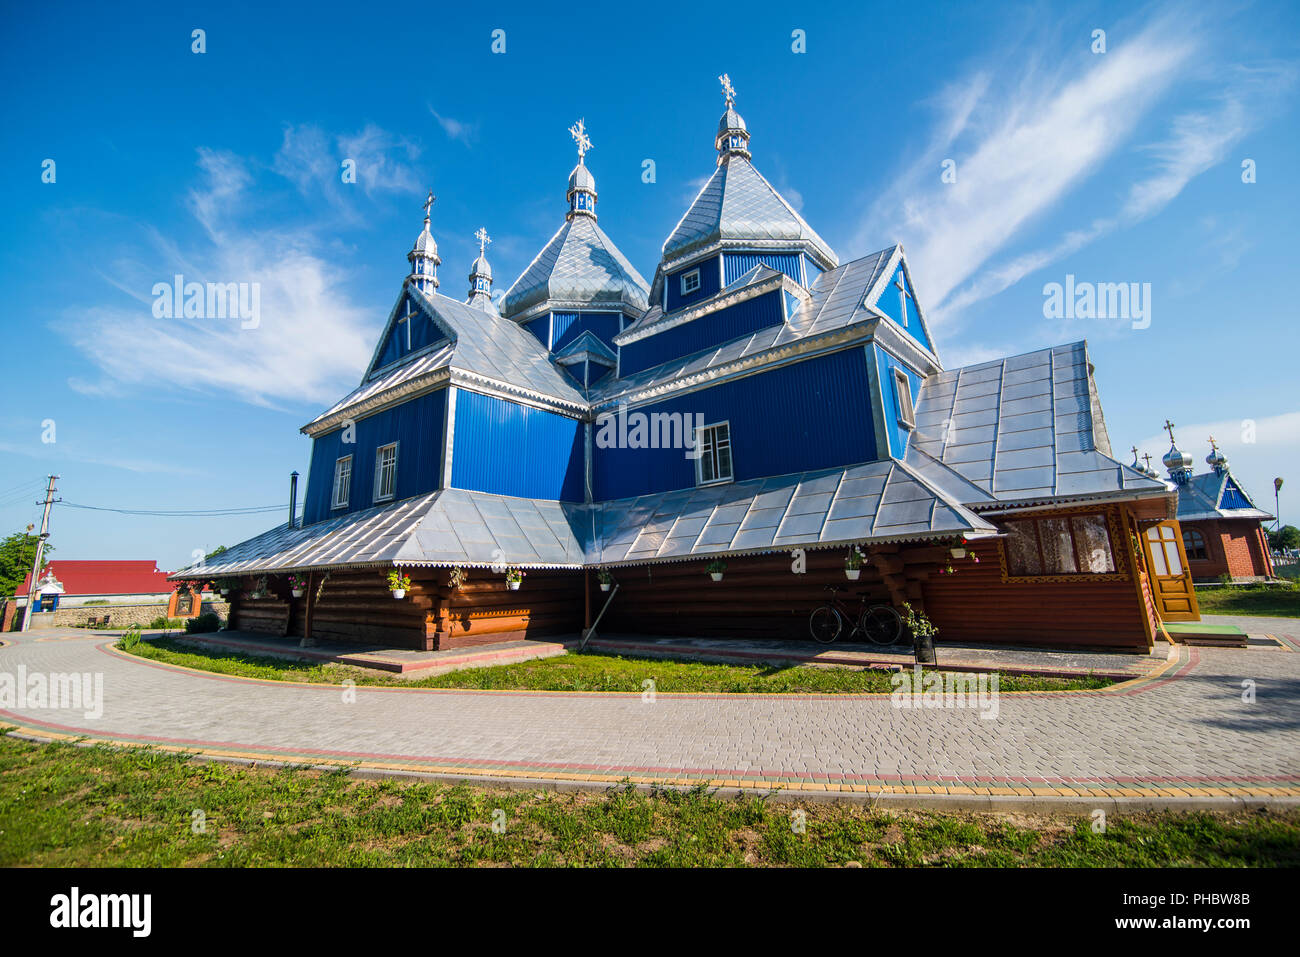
top-left (303, 389), bottom-right (447, 524)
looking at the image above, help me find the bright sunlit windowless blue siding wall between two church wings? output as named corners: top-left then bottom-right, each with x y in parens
top-left (451, 389), bottom-right (584, 502)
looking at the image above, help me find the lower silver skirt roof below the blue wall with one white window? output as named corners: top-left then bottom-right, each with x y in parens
top-left (588, 460), bottom-right (997, 564)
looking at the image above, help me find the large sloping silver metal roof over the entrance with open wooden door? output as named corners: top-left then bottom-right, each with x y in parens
top-left (911, 342), bottom-right (1169, 507)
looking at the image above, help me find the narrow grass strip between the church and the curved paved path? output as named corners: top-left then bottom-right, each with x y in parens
top-left (129, 638), bottom-right (1112, 694)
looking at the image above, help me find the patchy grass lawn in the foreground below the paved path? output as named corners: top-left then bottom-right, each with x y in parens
top-left (0, 735), bottom-right (1300, 867)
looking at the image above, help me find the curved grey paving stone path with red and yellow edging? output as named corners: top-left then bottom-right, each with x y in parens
top-left (0, 618), bottom-right (1300, 805)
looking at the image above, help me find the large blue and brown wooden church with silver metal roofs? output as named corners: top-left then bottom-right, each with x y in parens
top-left (183, 77), bottom-right (1197, 651)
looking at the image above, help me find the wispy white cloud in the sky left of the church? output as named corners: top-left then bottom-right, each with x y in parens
top-left (55, 151), bottom-right (380, 406)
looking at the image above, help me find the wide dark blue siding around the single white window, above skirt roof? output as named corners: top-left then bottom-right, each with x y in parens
top-left (595, 346), bottom-right (876, 499)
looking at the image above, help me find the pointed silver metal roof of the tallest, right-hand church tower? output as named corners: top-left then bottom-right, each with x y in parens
top-left (663, 153), bottom-right (839, 267)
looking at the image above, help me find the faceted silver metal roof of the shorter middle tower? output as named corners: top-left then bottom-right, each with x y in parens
top-left (502, 216), bottom-right (650, 320)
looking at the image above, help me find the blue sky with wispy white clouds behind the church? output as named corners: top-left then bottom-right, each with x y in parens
top-left (0, 3), bottom-right (1300, 568)
